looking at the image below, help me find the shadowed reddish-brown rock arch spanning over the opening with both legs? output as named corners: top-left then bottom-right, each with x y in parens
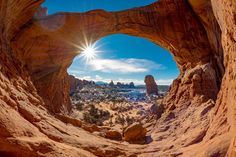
top-left (12, 0), bottom-right (223, 112)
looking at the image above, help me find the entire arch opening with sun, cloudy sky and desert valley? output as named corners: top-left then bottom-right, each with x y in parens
top-left (67, 34), bottom-right (179, 144)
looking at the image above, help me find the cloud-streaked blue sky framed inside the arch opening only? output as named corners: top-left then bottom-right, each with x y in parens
top-left (68, 34), bottom-right (179, 85)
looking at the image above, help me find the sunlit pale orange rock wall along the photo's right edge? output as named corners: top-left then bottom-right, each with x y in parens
top-left (211, 0), bottom-right (236, 156)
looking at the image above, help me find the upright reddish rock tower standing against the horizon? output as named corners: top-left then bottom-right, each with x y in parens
top-left (144, 75), bottom-right (158, 95)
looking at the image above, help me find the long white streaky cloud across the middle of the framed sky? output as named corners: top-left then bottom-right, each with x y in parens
top-left (88, 58), bottom-right (164, 73)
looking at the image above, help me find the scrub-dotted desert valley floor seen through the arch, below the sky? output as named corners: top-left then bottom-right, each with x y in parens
top-left (70, 76), bottom-right (169, 144)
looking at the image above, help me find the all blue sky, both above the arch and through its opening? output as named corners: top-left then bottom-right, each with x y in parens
top-left (43, 0), bottom-right (179, 84)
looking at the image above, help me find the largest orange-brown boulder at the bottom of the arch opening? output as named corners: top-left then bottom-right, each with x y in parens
top-left (123, 123), bottom-right (147, 144)
